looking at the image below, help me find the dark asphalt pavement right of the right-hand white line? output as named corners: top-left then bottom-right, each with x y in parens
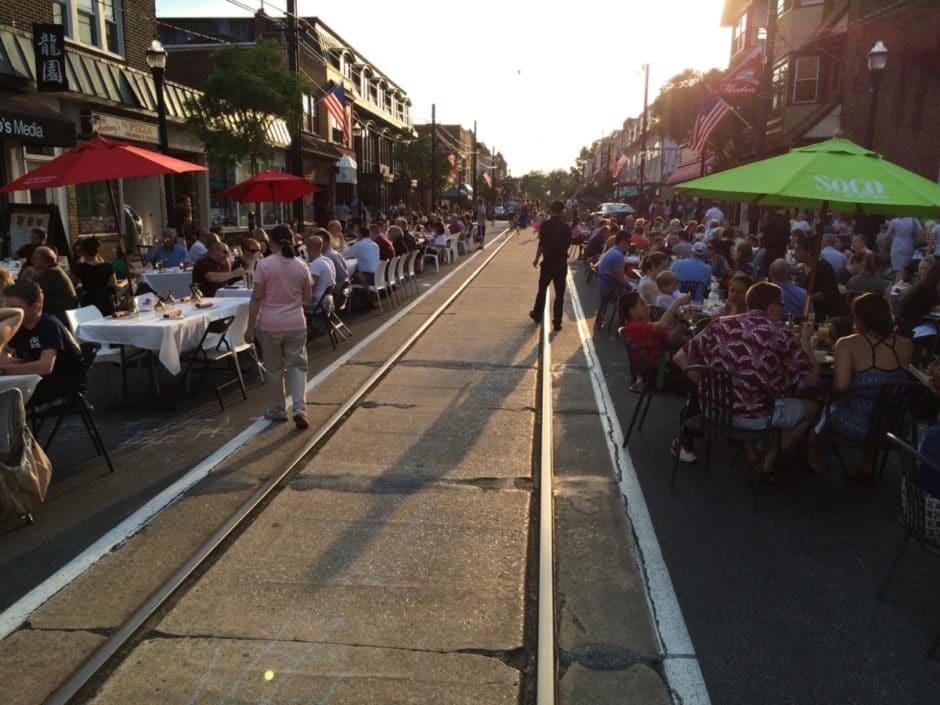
top-left (571, 263), bottom-right (940, 705)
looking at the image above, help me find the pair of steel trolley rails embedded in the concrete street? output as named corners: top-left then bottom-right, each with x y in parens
top-left (38, 231), bottom-right (558, 705)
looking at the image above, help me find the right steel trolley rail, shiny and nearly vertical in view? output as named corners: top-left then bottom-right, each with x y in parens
top-left (535, 296), bottom-right (557, 705)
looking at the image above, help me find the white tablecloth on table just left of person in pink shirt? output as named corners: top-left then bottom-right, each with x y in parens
top-left (78, 298), bottom-right (248, 374)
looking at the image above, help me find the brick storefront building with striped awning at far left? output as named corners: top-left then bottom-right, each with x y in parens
top-left (0, 0), bottom-right (206, 249)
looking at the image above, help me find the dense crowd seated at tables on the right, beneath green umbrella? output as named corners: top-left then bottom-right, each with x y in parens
top-left (596, 204), bottom-right (940, 486)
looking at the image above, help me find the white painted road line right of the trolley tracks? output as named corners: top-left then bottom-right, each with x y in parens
top-left (567, 270), bottom-right (711, 705)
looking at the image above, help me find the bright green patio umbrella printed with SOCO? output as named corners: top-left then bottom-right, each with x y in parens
top-left (676, 137), bottom-right (940, 216)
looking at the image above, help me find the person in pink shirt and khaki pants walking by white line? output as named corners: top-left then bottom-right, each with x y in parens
top-left (245, 225), bottom-right (313, 430)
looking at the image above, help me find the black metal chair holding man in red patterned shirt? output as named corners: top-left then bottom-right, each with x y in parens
top-left (671, 365), bottom-right (780, 502)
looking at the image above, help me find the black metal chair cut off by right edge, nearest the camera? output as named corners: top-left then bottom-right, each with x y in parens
top-left (878, 433), bottom-right (940, 658)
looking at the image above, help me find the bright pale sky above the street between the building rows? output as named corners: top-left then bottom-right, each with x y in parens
top-left (156, 0), bottom-right (731, 175)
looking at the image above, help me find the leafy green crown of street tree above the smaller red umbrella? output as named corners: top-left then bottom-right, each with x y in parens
top-left (187, 39), bottom-right (307, 172)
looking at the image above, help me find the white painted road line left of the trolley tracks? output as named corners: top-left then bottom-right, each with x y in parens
top-left (0, 230), bottom-right (509, 639)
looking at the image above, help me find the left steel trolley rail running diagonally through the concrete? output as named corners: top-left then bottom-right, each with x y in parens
top-left (45, 228), bottom-right (518, 705)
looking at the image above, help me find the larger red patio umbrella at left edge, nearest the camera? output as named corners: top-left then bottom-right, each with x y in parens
top-left (0, 137), bottom-right (207, 193)
